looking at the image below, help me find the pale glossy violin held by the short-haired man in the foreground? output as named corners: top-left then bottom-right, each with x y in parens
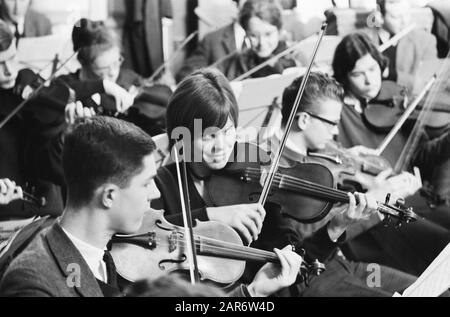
top-left (110, 210), bottom-right (324, 285)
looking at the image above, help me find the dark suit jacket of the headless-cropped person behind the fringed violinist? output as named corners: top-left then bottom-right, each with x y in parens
top-left (177, 23), bottom-right (237, 81)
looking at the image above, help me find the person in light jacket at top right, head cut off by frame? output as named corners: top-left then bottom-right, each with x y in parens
top-left (367, 0), bottom-right (437, 90)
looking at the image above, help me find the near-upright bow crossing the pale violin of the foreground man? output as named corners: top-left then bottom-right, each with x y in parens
top-left (174, 141), bottom-right (200, 285)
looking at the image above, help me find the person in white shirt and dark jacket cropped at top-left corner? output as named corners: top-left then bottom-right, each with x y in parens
top-left (0, 0), bottom-right (52, 40)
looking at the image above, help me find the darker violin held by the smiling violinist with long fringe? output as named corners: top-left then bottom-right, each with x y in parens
top-left (206, 144), bottom-right (418, 224)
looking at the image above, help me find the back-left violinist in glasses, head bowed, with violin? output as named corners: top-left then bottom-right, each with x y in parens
top-left (55, 19), bottom-right (171, 135)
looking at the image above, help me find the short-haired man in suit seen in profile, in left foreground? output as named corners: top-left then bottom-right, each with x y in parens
top-left (0, 117), bottom-right (301, 297)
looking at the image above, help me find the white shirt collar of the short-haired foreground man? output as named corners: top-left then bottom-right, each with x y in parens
top-left (62, 228), bottom-right (108, 283)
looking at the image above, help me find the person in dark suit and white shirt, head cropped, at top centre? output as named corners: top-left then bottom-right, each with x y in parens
top-left (176, 0), bottom-right (249, 82)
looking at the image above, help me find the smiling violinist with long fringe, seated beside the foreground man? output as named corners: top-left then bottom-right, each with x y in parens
top-left (153, 66), bottom-right (414, 296)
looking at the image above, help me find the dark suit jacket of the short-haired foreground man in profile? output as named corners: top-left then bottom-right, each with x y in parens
top-left (0, 224), bottom-right (103, 297)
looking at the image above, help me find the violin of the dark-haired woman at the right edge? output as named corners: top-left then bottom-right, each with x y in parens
top-left (364, 81), bottom-right (450, 133)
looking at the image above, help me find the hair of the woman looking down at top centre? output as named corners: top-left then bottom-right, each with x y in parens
top-left (239, 0), bottom-right (283, 30)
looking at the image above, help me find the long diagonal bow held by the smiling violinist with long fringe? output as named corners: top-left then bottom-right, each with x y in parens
top-left (259, 23), bottom-right (328, 206)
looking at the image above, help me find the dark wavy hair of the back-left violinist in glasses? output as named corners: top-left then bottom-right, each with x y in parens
top-left (72, 19), bottom-right (120, 66)
